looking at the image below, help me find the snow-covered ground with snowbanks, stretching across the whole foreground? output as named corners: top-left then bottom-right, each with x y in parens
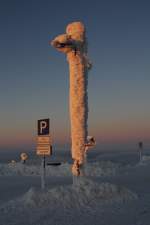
top-left (0, 149), bottom-right (150, 225)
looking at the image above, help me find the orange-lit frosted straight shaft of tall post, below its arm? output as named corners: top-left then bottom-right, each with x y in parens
top-left (68, 52), bottom-right (88, 164)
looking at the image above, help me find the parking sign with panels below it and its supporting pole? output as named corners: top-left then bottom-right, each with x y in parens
top-left (36, 119), bottom-right (52, 190)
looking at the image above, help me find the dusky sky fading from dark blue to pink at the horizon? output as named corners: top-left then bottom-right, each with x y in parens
top-left (0, 0), bottom-right (150, 150)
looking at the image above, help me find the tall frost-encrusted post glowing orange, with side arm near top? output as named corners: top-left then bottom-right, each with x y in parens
top-left (51, 22), bottom-right (91, 176)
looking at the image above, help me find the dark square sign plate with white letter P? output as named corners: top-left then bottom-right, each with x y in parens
top-left (38, 119), bottom-right (49, 135)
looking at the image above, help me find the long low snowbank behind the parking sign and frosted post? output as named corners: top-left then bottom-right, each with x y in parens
top-left (0, 161), bottom-right (120, 176)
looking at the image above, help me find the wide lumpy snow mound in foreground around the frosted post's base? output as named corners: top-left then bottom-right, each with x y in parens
top-left (0, 177), bottom-right (137, 213)
